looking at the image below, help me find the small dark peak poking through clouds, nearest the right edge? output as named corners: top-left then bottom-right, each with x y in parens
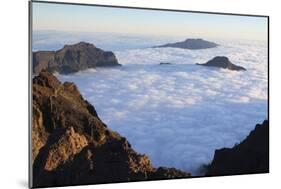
top-left (197, 56), bottom-right (246, 71)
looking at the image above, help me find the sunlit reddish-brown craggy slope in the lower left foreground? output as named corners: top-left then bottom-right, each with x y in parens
top-left (32, 70), bottom-right (190, 187)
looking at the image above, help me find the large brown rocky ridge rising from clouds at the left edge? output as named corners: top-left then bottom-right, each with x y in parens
top-left (33, 42), bottom-right (121, 74)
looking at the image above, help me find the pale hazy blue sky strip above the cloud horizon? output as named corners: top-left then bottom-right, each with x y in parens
top-left (33, 2), bottom-right (267, 40)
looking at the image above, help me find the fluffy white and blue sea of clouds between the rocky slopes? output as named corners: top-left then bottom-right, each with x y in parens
top-left (34, 31), bottom-right (268, 175)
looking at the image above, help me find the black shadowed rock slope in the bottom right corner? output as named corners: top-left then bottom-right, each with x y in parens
top-left (206, 120), bottom-right (269, 176)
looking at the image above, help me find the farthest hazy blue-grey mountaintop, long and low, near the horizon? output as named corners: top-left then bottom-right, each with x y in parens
top-left (154, 39), bottom-right (218, 50)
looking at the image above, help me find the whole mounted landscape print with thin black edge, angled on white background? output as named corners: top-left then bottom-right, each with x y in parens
top-left (29, 1), bottom-right (269, 188)
